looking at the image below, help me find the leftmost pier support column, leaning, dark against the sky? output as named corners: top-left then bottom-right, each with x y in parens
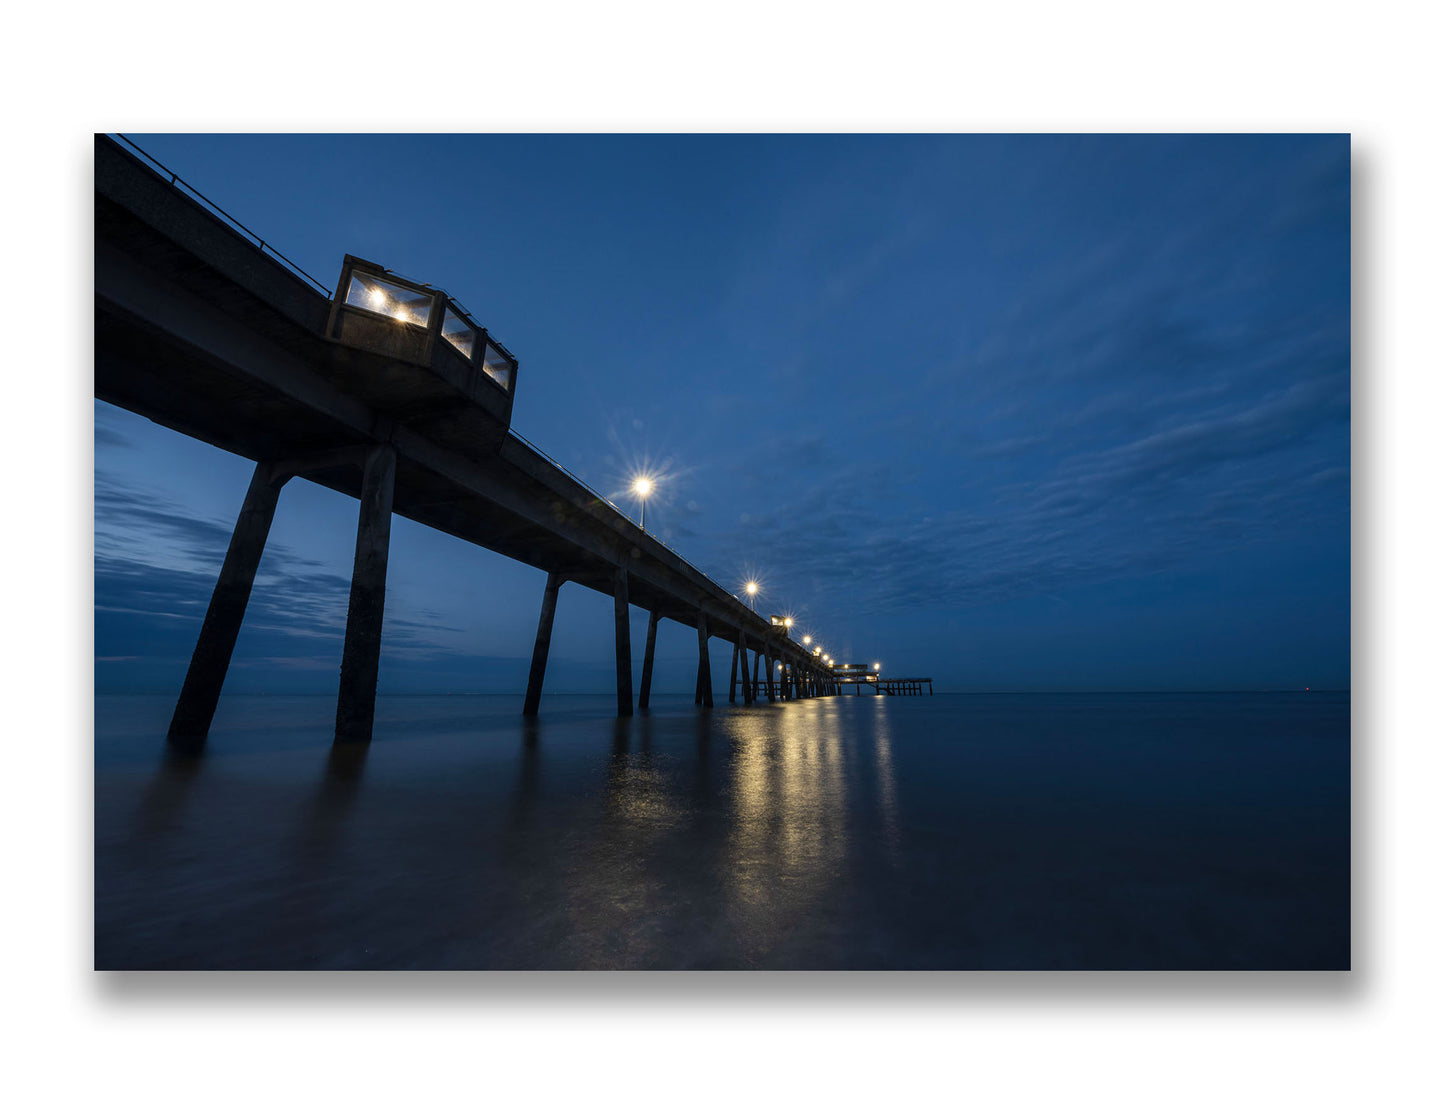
top-left (166, 464), bottom-right (286, 747)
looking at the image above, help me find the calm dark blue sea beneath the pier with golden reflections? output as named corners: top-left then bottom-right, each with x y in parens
top-left (95, 692), bottom-right (1350, 970)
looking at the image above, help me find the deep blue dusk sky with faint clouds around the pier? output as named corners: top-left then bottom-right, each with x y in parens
top-left (95, 134), bottom-right (1350, 694)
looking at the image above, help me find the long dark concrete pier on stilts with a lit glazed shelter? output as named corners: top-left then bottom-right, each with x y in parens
top-left (95, 136), bottom-right (867, 746)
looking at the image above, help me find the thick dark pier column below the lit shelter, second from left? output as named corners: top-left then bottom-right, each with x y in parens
top-left (337, 445), bottom-right (396, 744)
